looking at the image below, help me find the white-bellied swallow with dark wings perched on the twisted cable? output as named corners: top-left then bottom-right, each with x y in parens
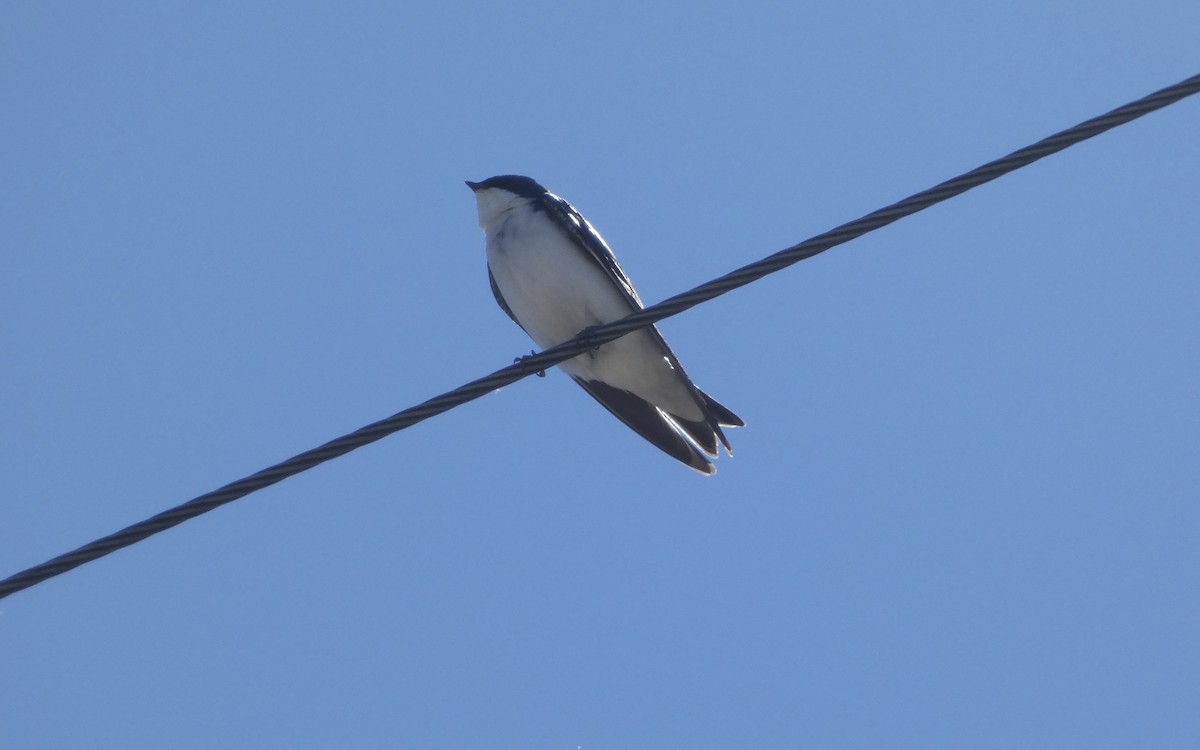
top-left (467, 174), bottom-right (745, 475)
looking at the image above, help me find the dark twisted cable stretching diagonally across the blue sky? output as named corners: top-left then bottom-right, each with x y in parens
top-left (0, 70), bottom-right (1200, 599)
